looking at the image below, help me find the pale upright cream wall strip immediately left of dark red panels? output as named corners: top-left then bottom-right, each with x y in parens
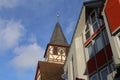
top-left (75, 35), bottom-right (87, 80)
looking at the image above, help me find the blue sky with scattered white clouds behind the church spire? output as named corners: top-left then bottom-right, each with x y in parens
top-left (0, 0), bottom-right (84, 80)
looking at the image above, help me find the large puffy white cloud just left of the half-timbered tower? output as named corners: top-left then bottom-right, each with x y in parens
top-left (12, 43), bottom-right (44, 69)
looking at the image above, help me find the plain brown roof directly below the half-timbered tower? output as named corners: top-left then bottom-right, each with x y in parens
top-left (37, 61), bottom-right (64, 80)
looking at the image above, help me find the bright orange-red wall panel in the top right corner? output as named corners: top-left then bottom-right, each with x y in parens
top-left (105, 0), bottom-right (120, 32)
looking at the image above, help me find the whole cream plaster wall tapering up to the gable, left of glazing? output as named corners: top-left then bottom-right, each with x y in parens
top-left (64, 6), bottom-right (87, 80)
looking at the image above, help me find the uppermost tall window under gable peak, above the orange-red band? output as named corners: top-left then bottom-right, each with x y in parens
top-left (90, 11), bottom-right (99, 32)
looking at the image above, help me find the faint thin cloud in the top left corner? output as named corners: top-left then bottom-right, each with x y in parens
top-left (0, 0), bottom-right (20, 8)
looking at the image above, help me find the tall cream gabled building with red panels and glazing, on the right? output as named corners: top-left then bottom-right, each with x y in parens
top-left (64, 0), bottom-right (120, 80)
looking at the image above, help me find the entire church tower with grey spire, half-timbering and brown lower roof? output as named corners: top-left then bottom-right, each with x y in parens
top-left (35, 15), bottom-right (69, 80)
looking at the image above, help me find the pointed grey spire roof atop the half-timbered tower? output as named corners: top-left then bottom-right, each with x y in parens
top-left (50, 22), bottom-right (68, 46)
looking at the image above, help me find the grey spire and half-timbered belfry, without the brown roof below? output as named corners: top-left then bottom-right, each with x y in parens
top-left (44, 22), bottom-right (69, 64)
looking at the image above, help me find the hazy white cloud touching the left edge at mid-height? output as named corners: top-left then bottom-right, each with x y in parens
top-left (0, 19), bottom-right (24, 52)
